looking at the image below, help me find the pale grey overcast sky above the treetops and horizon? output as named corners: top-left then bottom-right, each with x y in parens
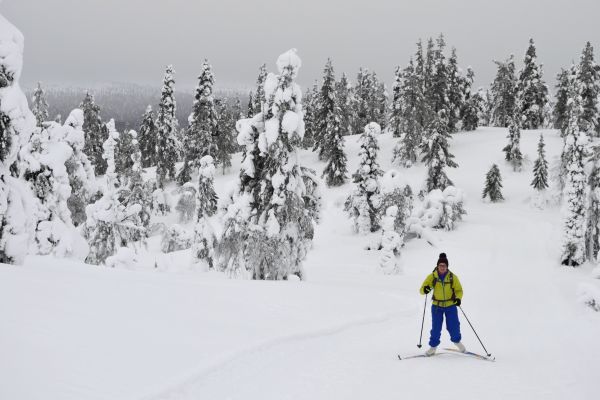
top-left (0, 0), bottom-right (600, 88)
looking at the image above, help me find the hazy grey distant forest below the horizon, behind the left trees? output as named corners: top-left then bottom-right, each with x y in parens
top-left (25, 84), bottom-right (248, 132)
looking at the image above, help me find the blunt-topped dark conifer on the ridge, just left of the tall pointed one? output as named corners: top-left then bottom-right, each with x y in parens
top-left (491, 55), bottom-right (517, 127)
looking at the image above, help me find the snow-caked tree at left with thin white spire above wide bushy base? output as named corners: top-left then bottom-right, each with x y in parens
top-left (85, 120), bottom-right (143, 265)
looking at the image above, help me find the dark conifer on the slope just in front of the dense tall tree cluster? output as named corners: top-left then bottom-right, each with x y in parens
top-left (421, 110), bottom-right (458, 192)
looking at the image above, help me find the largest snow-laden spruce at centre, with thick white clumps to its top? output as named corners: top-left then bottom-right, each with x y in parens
top-left (218, 49), bottom-right (320, 279)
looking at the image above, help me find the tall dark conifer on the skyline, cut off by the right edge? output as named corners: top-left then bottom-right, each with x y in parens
top-left (577, 42), bottom-right (600, 136)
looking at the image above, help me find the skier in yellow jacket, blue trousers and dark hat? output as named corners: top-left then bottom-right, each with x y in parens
top-left (420, 253), bottom-right (466, 356)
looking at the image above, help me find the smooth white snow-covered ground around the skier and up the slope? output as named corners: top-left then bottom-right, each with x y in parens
top-left (0, 128), bottom-right (600, 400)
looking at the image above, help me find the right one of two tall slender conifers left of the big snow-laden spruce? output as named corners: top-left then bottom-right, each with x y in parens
top-left (177, 60), bottom-right (218, 185)
